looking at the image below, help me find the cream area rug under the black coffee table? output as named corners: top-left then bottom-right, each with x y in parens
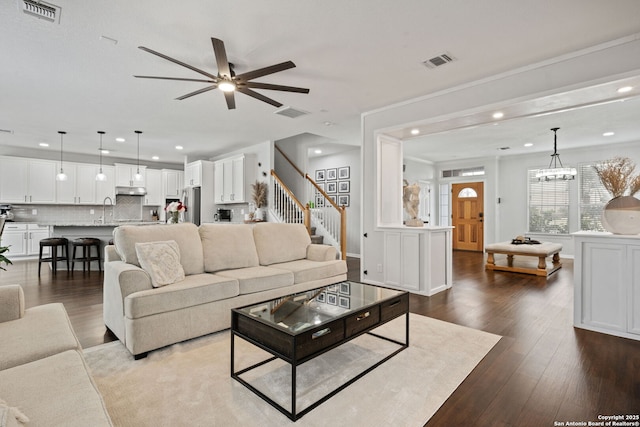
top-left (85, 314), bottom-right (500, 427)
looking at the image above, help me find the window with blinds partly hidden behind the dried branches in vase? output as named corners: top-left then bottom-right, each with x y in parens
top-left (578, 162), bottom-right (611, 231)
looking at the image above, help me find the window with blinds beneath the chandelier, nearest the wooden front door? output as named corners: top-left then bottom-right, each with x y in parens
top-left (528, 170), bottom-right (570, 234)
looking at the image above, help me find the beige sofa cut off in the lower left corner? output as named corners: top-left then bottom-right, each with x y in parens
top-left (0, 285), bottom-right (112, 427)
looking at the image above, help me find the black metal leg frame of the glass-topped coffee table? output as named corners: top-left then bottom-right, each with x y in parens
top-left (231, 311), bottom-right (409, 422)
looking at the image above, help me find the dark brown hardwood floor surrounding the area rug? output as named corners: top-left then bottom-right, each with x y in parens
top-left (0, 252), bottom-right (640, 427)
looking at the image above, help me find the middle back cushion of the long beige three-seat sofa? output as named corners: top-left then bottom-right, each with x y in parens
top-left (199, 224), bottom-right (259, 273)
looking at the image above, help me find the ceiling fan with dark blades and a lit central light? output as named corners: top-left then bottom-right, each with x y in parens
top-left (134, 37), bottom-right (309, 110)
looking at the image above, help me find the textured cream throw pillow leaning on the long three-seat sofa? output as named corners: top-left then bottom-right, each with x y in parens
top-left (136, 240), bottom-right (184, 288)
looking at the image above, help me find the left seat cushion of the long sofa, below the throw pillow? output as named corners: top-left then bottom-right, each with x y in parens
top-left (124, 273), bottom-right (239, 319)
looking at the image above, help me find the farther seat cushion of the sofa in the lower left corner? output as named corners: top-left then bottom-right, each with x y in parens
top-left (0, 303), bottom-right (80, 372)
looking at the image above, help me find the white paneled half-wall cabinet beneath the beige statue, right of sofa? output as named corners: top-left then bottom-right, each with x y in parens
top-left (378, 227), bottom-right (452, 296)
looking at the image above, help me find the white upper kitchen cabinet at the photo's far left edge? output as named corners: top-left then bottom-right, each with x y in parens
top-left (0, 157), bottom-right (57, 203)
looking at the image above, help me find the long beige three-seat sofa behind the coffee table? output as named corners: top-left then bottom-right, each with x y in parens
top-left (104, 223), bottom-right (347, 358)
